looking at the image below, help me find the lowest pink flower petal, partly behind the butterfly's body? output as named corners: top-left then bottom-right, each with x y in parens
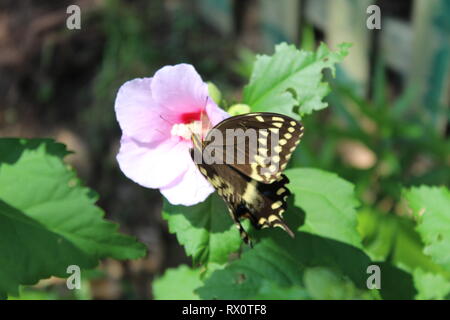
top-left (160, 160), bottom-right (214, 206)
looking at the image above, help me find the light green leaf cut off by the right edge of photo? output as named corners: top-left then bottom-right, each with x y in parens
top-left (404, 186), bottom-right (450, 271)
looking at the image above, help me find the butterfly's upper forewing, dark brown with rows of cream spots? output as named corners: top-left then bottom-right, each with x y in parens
top-left (204, 112), bottom-right (303, 184)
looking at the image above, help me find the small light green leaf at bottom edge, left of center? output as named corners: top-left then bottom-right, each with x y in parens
top-left (153, 265), bottom-right (202, 300)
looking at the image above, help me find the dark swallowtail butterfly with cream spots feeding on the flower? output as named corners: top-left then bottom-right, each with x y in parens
top-left (191, 112), bottom-right (303, 246)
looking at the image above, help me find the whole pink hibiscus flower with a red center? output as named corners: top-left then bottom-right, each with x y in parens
top-left (115, 64), bottom-right (229, 205)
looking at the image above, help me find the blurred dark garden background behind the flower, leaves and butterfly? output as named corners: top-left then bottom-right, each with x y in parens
top-left (0, 0), bottom-right (450, 299)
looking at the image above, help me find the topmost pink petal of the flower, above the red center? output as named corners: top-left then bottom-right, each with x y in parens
top-left (151, 63), bottom-right (208, 120)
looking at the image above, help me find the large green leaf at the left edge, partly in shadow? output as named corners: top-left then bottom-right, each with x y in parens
top-left (0, 139), bottom-right (145, 295)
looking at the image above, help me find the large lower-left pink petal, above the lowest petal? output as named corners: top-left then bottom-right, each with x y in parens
top-left (117, 135), bottom-right (192, 188)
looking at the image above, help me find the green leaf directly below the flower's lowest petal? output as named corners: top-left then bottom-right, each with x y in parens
top-left (163, 193), bottom-right (242, 265)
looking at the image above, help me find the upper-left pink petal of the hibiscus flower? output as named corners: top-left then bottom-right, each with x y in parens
top-left (114, 78), bottom-right (170, 142)
